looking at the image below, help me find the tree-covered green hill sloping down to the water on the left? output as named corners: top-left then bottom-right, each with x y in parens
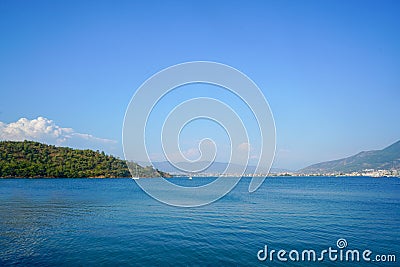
top-left (0, 141), bottom-right (168, 178)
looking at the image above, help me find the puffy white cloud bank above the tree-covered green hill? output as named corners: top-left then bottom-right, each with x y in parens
top-left (0, 117), bottom-right (117, 153)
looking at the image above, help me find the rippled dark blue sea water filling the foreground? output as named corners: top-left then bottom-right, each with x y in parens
top-left (0, 177), bottom-right (400, 266)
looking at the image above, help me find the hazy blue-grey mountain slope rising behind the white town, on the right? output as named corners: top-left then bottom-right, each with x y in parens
top-left (298, 140), bottom-right (400, 174)
